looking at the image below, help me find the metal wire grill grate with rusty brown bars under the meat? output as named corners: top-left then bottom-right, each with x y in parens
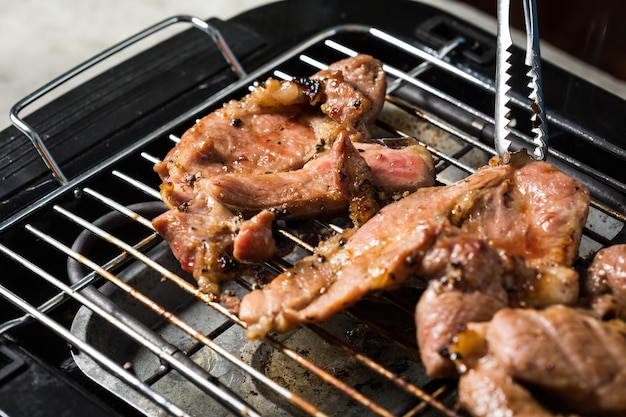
top-left (0, 12), bottom-right (626, 416)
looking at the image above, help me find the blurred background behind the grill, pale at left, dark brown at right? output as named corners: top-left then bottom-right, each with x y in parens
top-left (0, 0), bottom-right (626, 130)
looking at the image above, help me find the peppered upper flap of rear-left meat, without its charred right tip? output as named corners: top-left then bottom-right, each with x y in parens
top-left (154, 79), bottom-right (322, 208)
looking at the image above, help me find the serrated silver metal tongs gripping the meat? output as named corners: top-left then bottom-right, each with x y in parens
top-left (495, 0), bottom-right (548, 164)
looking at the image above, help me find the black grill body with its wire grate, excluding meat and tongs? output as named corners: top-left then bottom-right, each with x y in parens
top-left (0, 0), bottom-right (626, 416)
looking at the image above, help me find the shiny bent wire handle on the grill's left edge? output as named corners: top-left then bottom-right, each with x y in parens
top-left (9, 15), bottom-right (247, 185)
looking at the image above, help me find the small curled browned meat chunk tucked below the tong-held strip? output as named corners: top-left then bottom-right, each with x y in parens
top-left (415, 231), bottom-right (511, 378)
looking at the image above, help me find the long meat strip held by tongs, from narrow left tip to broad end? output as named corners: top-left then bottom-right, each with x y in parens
top-left (240, 156), bottom-right (589, 337)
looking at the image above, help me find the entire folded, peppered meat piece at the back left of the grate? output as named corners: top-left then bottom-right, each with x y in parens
top-left (153, 55), bottom-right (433, 293)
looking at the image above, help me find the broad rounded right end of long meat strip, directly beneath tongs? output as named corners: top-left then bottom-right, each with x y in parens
top-left (456, 155), bottom-right (589, 282)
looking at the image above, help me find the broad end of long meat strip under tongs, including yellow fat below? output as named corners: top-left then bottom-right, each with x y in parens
top-left (452, 153), bottom-right (589, 307)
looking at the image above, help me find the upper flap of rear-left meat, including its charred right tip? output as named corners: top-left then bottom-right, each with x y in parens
top-left (155, 55), bottom-right (386, 211)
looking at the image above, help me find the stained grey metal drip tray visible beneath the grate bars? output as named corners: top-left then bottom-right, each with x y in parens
top-left (71, 243), bottom-right (438, 416)
